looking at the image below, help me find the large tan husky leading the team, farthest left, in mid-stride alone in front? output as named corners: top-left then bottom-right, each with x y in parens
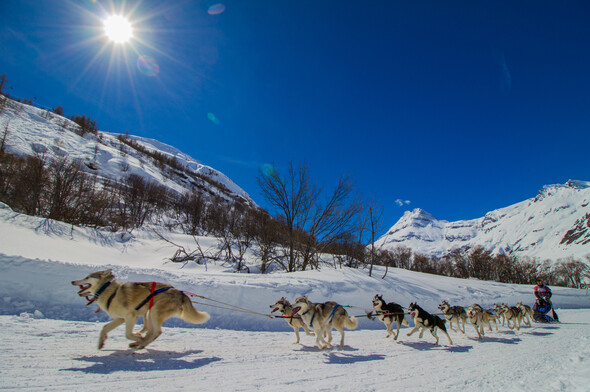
top-left (72, 269), bottom-right (209, 350)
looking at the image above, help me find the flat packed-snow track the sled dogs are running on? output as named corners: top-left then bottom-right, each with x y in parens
top-left (0, 309), bottom-right (590, 391)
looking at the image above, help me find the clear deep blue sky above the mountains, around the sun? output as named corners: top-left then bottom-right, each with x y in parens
top-left (0, 0), bottom-right (590, 231)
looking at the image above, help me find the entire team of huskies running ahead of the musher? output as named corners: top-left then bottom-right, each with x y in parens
top-left (72, 270), bottom-right (544, 350)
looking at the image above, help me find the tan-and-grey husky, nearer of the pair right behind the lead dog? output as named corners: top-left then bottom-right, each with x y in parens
top-left (292, 296), bottom-right (358, 350)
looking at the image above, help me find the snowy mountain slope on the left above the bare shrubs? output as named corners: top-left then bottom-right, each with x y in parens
top-left (0, 99), bottom-right (255, 206)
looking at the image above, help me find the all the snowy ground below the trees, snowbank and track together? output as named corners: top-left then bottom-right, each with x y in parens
top-left (0, 205), bottom-right (590, 391)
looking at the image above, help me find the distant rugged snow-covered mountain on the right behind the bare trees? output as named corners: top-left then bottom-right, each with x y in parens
top-left (376, 180), bottom-right (590, 260)
